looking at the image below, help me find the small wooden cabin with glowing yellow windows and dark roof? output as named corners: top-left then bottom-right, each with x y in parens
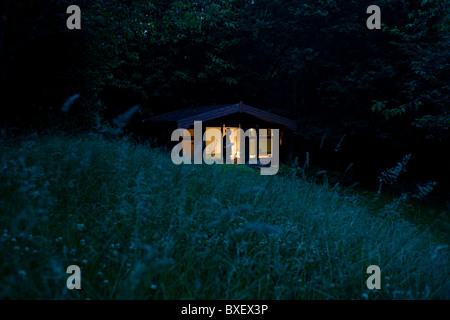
top-left (143, 102), bottom-right (297, 162)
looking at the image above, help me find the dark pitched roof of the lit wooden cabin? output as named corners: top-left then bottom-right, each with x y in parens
top-left (143, 102), bottom-right (297, 131)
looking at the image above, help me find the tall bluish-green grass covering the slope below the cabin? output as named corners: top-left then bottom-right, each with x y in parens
top-left (0, 134), bottom-right (450, 299)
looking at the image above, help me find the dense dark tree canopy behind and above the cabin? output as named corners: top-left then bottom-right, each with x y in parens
top-left (0, 0), bottom-right (450, 200)
